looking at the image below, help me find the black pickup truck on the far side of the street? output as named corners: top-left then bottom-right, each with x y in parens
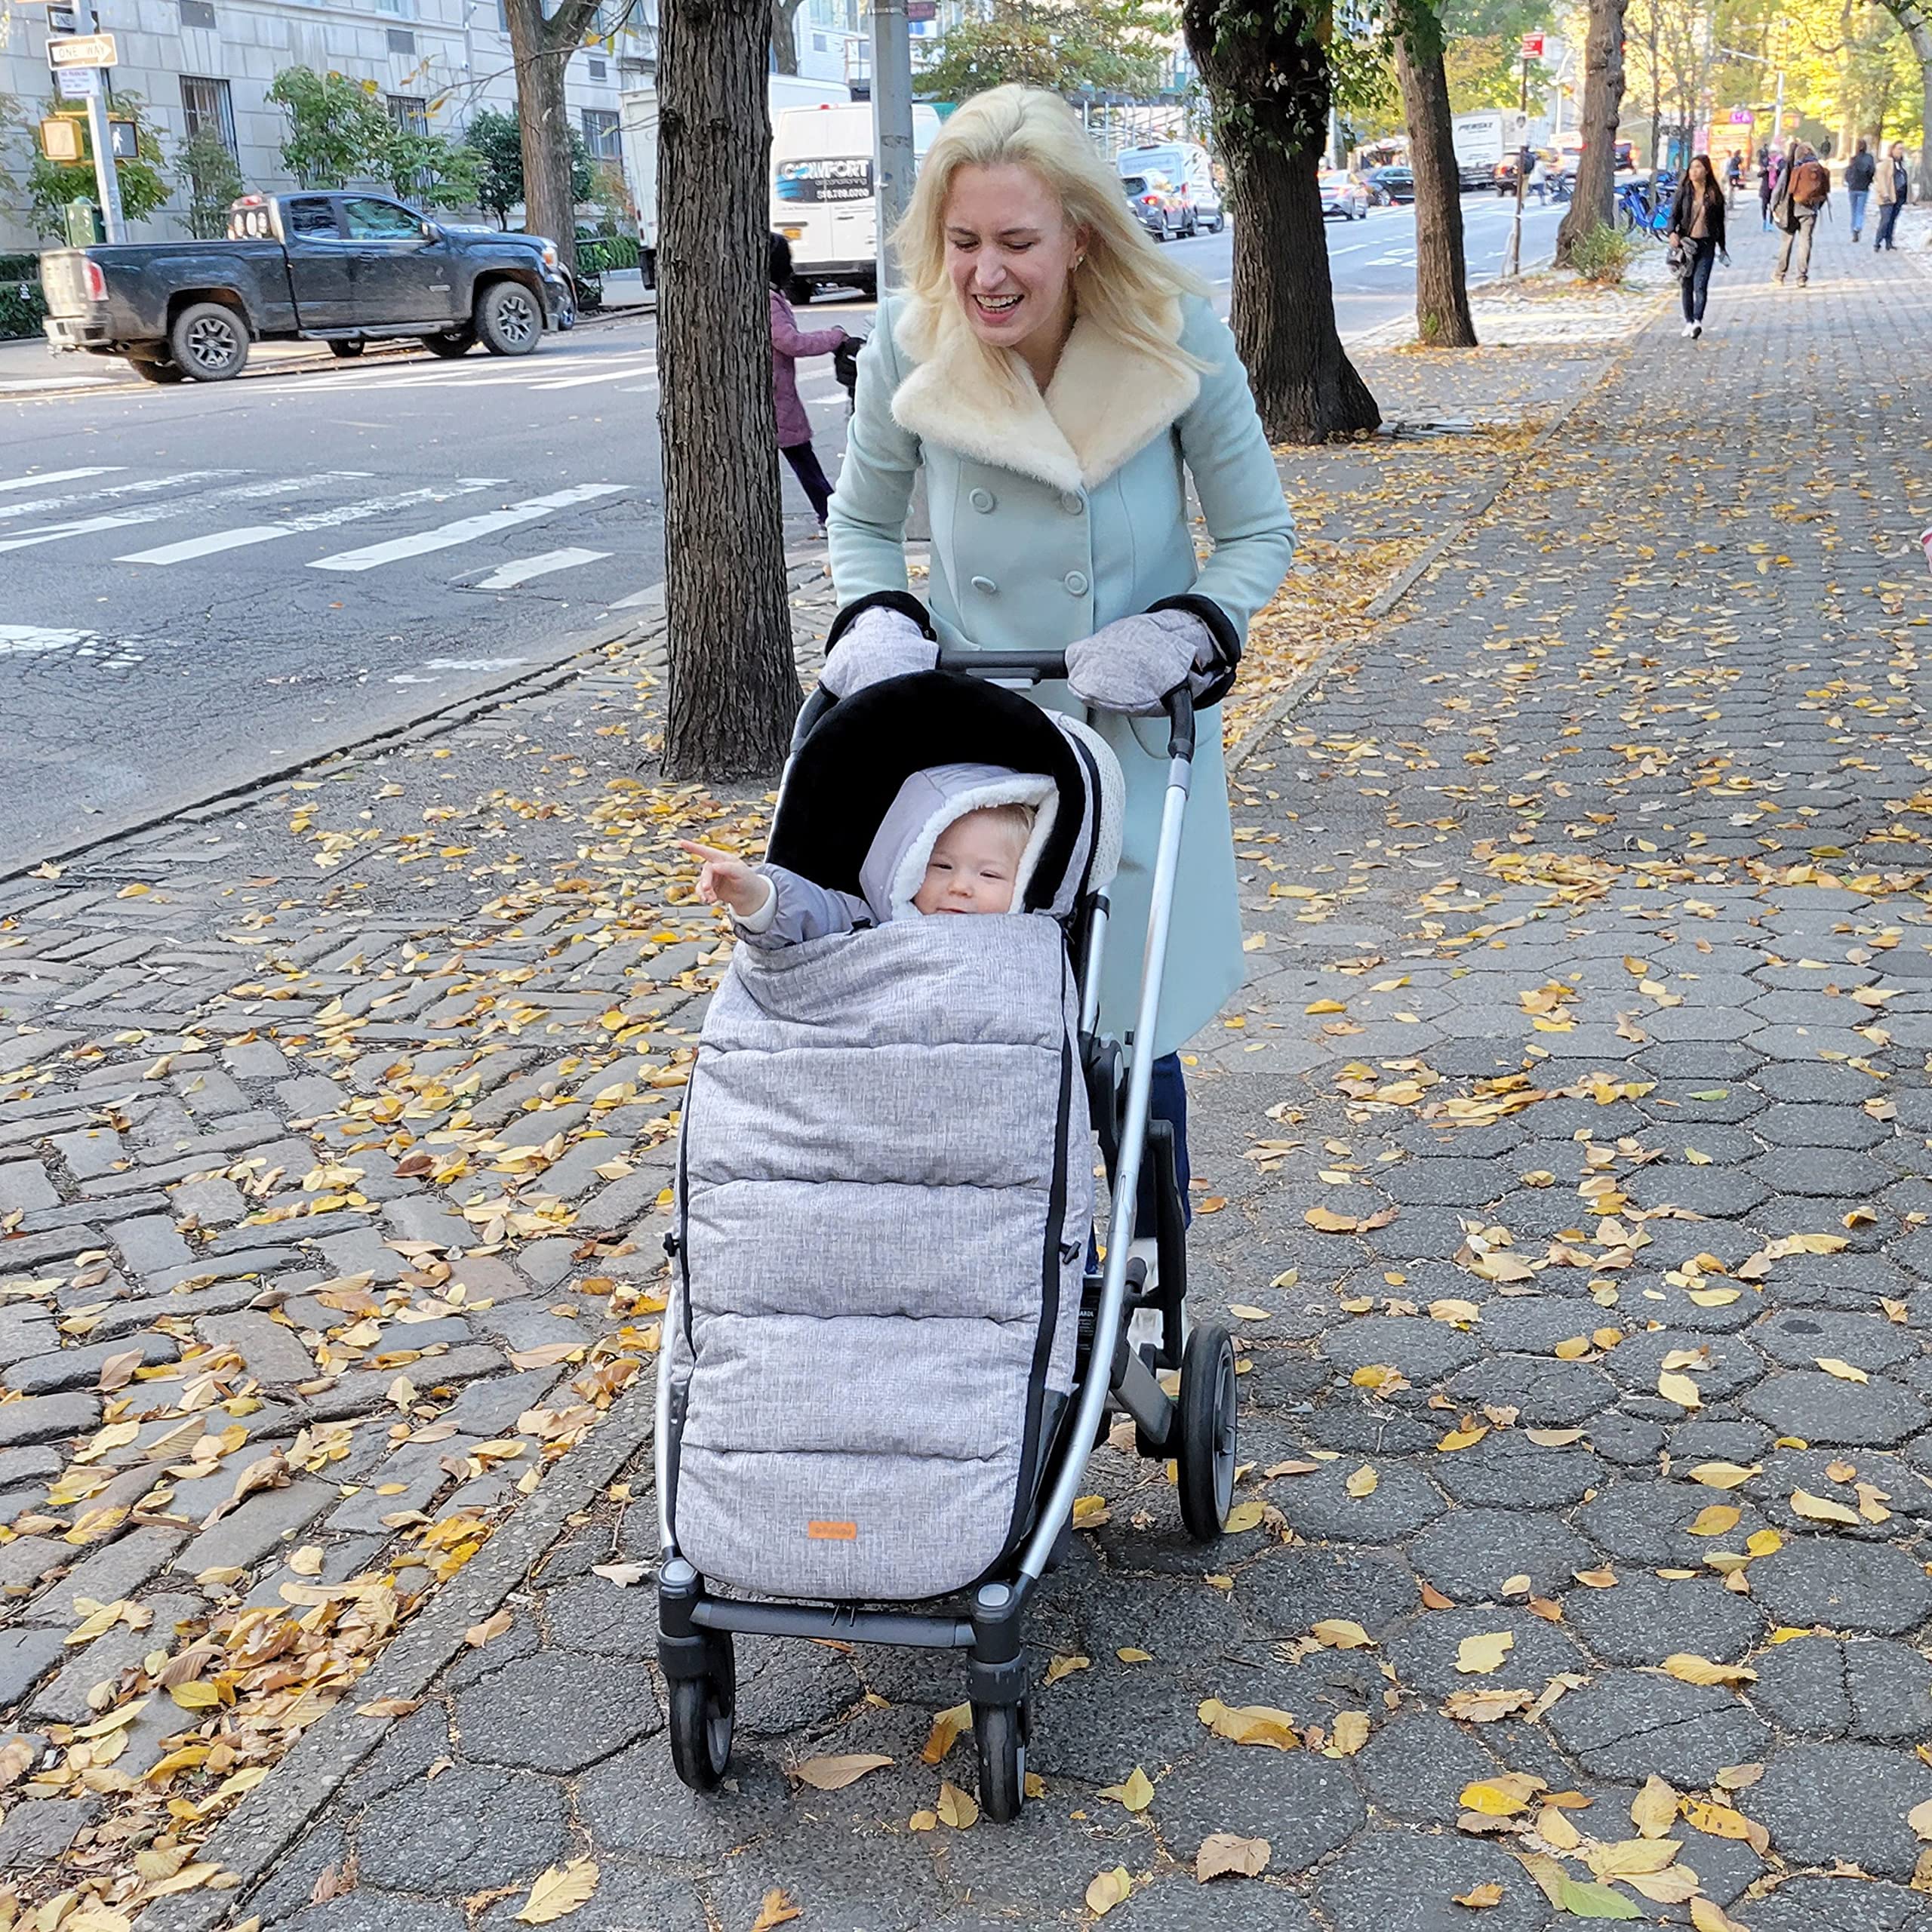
top-left (41, 193), bottom-right (577, 383)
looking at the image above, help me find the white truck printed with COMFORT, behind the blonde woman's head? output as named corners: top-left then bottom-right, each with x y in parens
top-left (771, 100), bottom-right (939, 301)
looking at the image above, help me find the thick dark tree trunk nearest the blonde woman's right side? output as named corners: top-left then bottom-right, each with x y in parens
top-left (1180, 0), bottom-right (1381, 442)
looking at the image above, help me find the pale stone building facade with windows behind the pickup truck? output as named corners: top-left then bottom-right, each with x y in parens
top-left (0, 0), bottom-right (657, 251)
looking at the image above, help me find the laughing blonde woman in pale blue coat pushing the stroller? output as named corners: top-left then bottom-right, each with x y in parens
top-left (825, 87), bottom-right (1294, 1213)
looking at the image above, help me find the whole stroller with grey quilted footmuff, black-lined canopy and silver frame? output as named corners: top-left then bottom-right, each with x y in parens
top-left (657, 651), bottom-right (1235, 1820)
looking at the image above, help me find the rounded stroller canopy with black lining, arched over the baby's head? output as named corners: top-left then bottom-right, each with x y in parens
top-left (767, 670), bottom-right (1124, 918)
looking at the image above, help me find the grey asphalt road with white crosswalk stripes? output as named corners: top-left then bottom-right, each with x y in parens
top-left (0, 195), bottom-right (1557, 867)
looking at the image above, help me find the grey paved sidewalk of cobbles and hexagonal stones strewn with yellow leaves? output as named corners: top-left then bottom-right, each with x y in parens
top-left (0, 219), bottom-right (1932, 1932)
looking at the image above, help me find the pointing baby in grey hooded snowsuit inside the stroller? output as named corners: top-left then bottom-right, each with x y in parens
top-left (678, 765), bottom-right (1055, 946)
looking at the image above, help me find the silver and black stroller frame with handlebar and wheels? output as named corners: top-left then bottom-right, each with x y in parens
top-left (657, 651), bottom-right (1236, 1822)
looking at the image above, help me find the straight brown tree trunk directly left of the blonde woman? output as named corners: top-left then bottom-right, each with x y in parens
top-left (657, 0), bottom-right (798, 780)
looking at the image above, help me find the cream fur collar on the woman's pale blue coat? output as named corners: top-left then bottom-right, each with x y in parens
top-left (893, 296), bottom-right (1200, 491)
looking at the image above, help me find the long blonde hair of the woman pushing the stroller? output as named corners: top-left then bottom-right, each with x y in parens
top-left (893, 83), bottom-right (1211, 384)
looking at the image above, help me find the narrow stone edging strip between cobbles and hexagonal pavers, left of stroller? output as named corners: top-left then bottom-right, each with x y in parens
top-left (135, 1374), bottom-right (657, 1932)
